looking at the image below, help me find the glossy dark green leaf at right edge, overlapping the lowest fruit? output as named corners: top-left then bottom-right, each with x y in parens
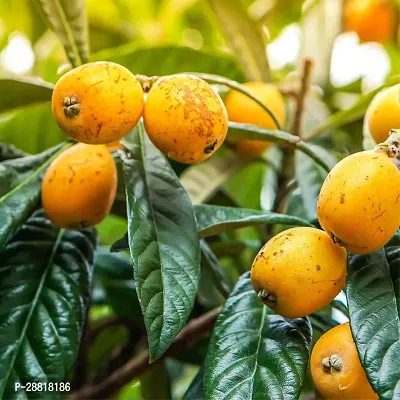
top-left (347, 230), bottom-right (400, 400)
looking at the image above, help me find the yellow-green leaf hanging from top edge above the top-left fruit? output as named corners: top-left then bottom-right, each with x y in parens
top-left (35, 0), bottom-right (89, 67)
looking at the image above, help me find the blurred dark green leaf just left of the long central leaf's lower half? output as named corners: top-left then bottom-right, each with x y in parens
top-left (94, 250), bottom-right (141, 321)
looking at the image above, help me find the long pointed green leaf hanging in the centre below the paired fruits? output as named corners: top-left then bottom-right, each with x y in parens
top-left (121, 124), bottom-right (200, 361)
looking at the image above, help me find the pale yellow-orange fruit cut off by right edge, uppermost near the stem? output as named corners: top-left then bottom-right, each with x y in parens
top-left (364, 84), bottom-right (400, 143)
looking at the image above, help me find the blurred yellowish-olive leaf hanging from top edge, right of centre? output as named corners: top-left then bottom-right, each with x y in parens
top-left (208, 0), bottom-right (271, 82)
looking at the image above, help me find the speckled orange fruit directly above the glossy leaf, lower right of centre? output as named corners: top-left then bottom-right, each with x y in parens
top-left (251, 227), bottom-right (347, 318)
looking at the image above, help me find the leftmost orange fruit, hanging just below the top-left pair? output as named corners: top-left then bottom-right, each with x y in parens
top-left (42, 143), bottom-right (117, 229)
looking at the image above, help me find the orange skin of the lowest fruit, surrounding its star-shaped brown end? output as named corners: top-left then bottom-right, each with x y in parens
top-left (310, 323), bottom-right (378, 400)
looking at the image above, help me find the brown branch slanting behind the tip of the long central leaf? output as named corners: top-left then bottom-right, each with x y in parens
top-left (70, 308), bottom-right (221, 400)
